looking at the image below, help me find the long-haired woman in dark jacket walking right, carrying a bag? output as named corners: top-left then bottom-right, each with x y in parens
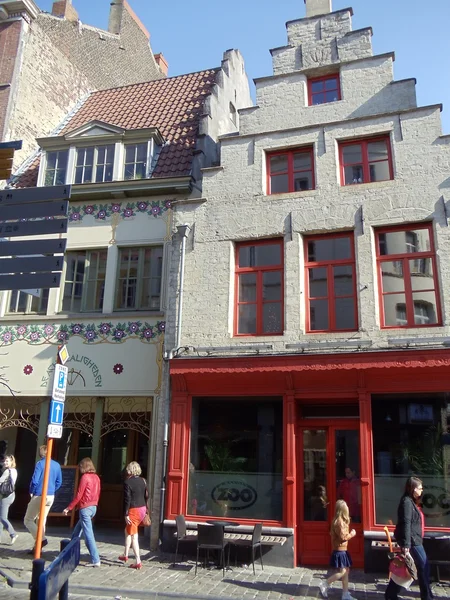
top-left (384, 477), bottom-right (433, 600)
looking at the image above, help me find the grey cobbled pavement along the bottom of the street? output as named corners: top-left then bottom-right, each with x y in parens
top-left (0, 528), bottom-right (450, 600)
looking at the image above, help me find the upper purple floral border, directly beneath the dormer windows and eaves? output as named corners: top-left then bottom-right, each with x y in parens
top-left (69, 200), bottom-right (172, 223)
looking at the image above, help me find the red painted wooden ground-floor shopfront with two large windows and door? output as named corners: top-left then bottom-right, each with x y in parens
top-left (165, 349), bottom-right (450, 566)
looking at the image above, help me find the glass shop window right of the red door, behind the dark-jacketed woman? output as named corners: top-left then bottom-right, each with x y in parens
top-left (372, 393), bottom-right (450, 528)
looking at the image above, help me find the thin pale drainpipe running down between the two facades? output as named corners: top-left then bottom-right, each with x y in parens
top-left (159, 223), bottom-right (191, 528)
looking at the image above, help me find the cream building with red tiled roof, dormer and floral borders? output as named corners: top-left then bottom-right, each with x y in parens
top-left (0, 50), bottom-right (251, 541)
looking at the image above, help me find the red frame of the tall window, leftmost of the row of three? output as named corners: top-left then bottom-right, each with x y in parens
top-left (234, 238), bottom-right (284, 337)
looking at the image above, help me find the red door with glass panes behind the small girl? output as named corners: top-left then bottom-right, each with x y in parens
top-left (297, 419), bottom-right (364, 567)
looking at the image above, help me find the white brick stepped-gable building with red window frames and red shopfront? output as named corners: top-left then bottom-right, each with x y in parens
top-left (166, 0), bottom-right (450, 567)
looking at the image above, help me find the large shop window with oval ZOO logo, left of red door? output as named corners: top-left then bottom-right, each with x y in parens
top-left (187, 398), bottom-right (283, 521)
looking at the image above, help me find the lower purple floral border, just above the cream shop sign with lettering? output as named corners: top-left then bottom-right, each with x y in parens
top-left (0, 321), bottom-right (166, 346)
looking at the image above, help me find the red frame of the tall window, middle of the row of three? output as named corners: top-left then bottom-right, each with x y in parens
top-left (304, 231), bottom-right (359, 333)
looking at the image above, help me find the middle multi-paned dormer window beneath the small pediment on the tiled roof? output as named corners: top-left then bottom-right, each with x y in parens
top-left (74, 144), bottom-right (114, 183)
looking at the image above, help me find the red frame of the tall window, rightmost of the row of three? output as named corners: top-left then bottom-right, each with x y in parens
top-left (375, 223), bottom-right (442, 329)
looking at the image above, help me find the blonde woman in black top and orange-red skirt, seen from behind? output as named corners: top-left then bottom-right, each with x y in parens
top-left (119, 461), bottom-right (148, 569)
